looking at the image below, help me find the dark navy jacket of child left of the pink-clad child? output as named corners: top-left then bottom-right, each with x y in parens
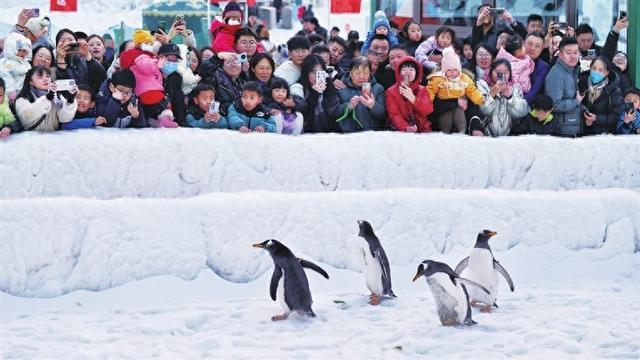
top-left (96, 79), bottom-right (149, 128)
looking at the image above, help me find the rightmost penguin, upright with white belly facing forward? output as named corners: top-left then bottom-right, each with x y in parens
top-left (456, 230), bottom-right (515, 312)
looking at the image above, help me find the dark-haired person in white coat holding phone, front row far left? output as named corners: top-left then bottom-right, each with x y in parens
top-left (15, 66), bottom-right (78, 131)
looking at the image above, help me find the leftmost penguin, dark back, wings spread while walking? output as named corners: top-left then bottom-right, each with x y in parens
top-left (253, 239), bottom-right (329, 321)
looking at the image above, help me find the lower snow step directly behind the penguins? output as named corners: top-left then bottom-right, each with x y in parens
top-left (0, 187), bottom-right (640, 297)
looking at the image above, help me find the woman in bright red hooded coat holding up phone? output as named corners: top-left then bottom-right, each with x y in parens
top-left (386, 56), bottom-right (433, 132)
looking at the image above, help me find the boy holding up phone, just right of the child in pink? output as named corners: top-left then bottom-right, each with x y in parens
top-left (187, 83), bottom-right (228, 129)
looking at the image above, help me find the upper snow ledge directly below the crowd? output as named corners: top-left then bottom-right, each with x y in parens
top-left (0, 129), bottom-right (640, 199)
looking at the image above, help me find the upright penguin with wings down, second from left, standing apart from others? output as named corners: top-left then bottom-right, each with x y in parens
top-left (358, 220), bottom-right (396, 305)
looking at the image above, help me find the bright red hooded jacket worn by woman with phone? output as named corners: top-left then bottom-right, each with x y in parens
top-left (386, 56), bottom-right (433, 132)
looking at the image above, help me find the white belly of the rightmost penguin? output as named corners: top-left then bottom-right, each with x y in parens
top-left (465, 248), bottom-right (498, 305)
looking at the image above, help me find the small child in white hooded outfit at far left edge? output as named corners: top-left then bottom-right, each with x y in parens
top-left (0, 33), bottom-right (31, 102)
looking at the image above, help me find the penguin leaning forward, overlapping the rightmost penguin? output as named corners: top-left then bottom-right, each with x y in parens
top-left (413, 260), bottom-right (489, 326)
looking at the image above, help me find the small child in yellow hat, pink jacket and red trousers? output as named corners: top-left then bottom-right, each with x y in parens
top-left (120, 30), bottom-right (178, 128)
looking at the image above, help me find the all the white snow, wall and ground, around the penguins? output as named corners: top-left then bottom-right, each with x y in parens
top-left (0, 129), bottom-right (640, 359)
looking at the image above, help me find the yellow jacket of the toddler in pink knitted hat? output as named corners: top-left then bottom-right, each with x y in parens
top-left (427, 71), bottom-right (484, 105)
